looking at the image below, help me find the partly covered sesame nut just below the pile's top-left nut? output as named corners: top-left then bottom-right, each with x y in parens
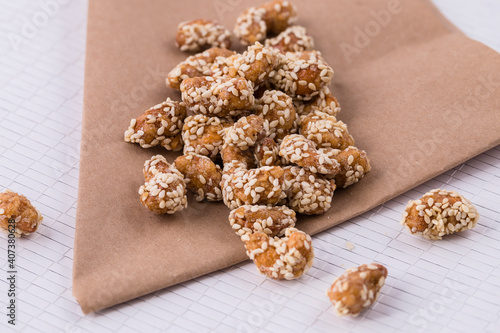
top-left (166, 47), bottom-right (236, 90)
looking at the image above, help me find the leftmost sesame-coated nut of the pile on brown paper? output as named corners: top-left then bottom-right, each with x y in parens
top-left (125, 98), bottom-right (186, 151)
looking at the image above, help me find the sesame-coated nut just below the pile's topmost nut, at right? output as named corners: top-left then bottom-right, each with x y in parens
top-left (265, 25), bottom-right (314, 53)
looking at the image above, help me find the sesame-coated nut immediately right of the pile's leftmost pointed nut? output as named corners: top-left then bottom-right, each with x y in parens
top-left (182, 114), bottom-right (224, 160)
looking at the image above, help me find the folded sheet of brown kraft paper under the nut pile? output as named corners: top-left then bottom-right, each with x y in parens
top-left (73, 0), bottom-right (500, 313)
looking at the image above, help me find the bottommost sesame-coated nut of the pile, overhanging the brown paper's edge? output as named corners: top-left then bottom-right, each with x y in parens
top-left (241, 228), bottom-right (314, 280)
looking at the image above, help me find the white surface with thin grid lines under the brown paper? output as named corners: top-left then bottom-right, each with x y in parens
top-left (0, 0), bottom-right (500, 333)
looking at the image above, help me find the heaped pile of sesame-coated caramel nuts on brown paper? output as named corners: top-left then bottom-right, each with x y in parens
top-left (125, 1), bottom-right (370, 280)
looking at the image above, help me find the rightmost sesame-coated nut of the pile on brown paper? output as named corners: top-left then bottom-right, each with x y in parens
top-left (330, 147), bottom-right (371, 188)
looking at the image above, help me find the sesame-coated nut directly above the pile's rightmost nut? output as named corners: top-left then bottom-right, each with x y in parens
top-left (300, 112), bottom-right (354, 150)
